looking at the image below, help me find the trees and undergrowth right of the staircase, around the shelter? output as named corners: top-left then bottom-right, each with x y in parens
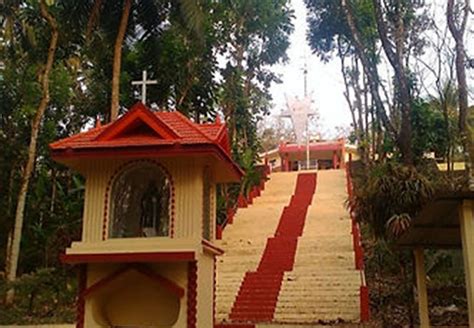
top-left (305, 0), bottom-right (473, 327)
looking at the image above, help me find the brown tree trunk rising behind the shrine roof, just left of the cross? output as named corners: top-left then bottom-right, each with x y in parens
top-left (110, 0), bottom-right (132, 121)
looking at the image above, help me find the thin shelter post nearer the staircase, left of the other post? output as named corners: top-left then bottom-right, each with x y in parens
top-left (413, 248), bottom-right (430, 328)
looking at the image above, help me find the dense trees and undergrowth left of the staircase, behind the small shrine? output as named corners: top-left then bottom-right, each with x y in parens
top-left (0, 0), bottom-right (293, 324)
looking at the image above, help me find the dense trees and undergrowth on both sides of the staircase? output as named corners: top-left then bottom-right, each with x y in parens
top-left (0, 0), bottom-right (474, 326)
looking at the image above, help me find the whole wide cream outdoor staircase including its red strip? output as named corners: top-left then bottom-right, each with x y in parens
top-left (216, 170), bottom-right (361, 327)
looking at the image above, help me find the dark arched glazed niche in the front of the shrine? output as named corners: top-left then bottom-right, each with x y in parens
top-left (108, 161), bottom-right (172, 238)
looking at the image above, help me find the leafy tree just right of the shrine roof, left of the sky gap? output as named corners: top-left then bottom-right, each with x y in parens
top-left (219, 0), bottom-right (293, 154)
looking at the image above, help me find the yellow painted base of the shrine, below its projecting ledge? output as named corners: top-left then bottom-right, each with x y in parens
top-left (84, 253), bottom-right (214, 328)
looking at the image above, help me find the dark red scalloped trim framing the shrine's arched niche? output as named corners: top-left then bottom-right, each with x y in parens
top-left (102, 159), bottom-right (175, 240)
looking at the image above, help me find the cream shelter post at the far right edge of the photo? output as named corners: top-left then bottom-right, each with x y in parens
top-left (459, 199), bottom-right (474, 327)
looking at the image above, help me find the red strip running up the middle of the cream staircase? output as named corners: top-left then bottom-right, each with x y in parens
top-left (225, 173), bottom-right (316, 327)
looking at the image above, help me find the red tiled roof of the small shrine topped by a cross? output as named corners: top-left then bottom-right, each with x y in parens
top-left (49, 103), bottom-right (242, 177)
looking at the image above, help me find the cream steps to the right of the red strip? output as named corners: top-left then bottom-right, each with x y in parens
top-left (273, 170), bottom-right (361, 323)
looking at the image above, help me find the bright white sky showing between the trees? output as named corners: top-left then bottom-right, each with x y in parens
top-left (271, 0), bottom-right (474, 138)
